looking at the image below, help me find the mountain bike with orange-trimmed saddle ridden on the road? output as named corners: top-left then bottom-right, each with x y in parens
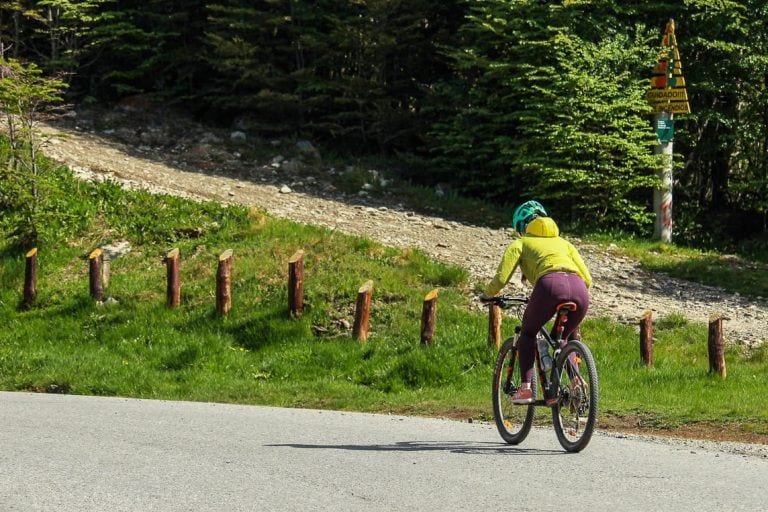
top-left (483, 295), bottom-right (600, 452)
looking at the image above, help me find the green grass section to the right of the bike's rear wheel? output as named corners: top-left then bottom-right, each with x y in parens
top-left (585, 319), bottom-right (768, 435)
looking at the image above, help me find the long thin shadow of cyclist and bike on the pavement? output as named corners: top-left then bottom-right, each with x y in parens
top-left (265, 441), bottom-right (567, 456)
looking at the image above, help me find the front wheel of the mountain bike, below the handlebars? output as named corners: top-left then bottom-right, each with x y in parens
top-left (492, 338), bottom-right (536, 444)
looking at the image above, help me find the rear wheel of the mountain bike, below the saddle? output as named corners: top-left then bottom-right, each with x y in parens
top-left (552, 340), bottom-right (600, 452)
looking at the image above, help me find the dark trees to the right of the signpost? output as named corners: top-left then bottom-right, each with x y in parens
top-left (664, 0), bottom-right (768, 250)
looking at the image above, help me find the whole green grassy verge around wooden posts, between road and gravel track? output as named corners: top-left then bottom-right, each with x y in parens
top-left (0, 166), bottom-right (768, 442)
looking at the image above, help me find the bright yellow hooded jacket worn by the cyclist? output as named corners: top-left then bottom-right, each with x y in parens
top-left (485, 217), bottom-right (592, 297)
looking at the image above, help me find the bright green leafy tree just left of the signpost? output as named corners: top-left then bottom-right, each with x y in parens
top-left (434, 0), bottom-right (655, 228)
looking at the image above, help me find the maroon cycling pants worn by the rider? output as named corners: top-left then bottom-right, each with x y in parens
top-left (517, 272), bottom-right (589, 382)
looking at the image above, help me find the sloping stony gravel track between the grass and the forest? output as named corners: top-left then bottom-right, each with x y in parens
top-left (36, 111), bottom-right (768, 345)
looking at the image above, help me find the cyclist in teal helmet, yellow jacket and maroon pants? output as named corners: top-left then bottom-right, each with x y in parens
top-left (481, 201), bottom-right (592, 404)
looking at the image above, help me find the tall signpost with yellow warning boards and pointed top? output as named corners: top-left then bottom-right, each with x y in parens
top-left (645, 20), bottom-right (691, 243)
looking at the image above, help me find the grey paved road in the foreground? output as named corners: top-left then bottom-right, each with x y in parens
top-left (0, 393), bottom-right (768, 512)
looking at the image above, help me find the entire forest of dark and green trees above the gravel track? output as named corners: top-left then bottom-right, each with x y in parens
top-left (0, 0), bottom-right (768, 260)
